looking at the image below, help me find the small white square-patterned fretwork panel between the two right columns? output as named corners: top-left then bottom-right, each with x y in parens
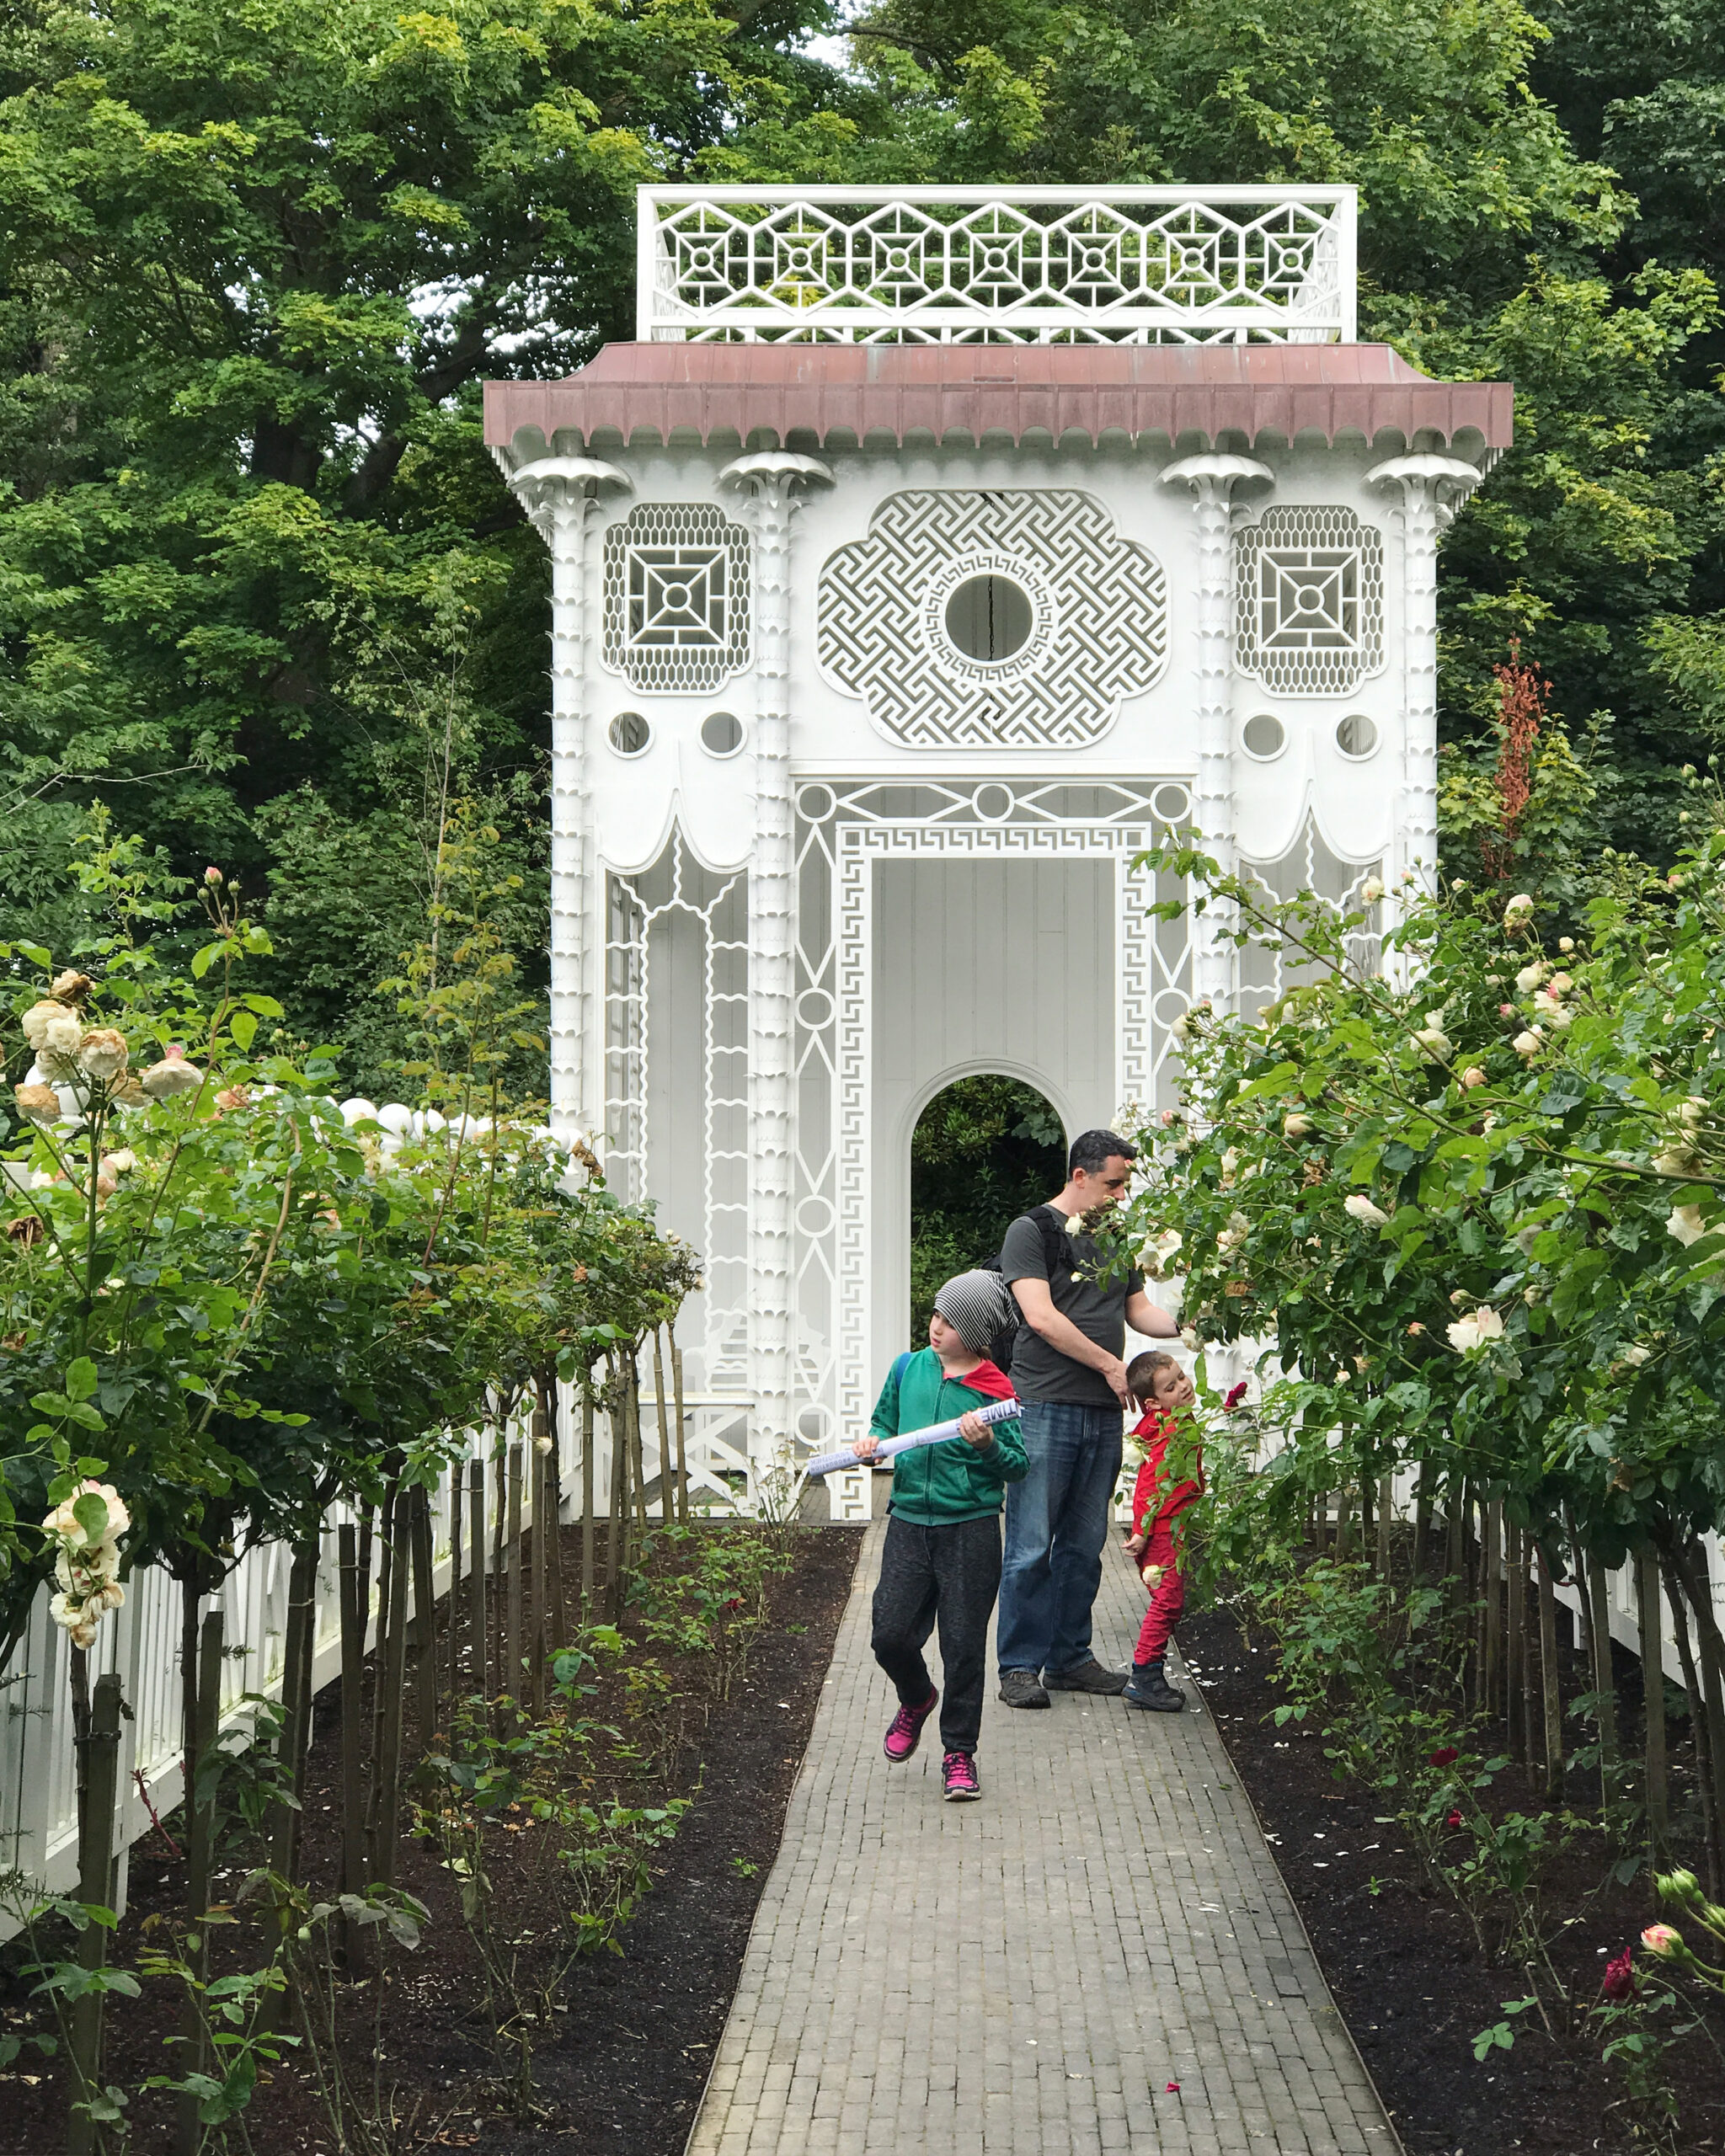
top-left (1236, 502), bottom-right (1385, 696)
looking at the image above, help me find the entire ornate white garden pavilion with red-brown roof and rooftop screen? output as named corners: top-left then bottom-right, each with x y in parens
top-left (485, 188), bottom-right (1512, 1460)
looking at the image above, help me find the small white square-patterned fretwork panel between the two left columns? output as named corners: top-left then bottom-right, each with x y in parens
top-left (604, 502), bottom-right (748, 696)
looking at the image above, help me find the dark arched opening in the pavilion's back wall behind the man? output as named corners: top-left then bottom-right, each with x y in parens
top-left (910, 1071), bottom-right (1067, 1348)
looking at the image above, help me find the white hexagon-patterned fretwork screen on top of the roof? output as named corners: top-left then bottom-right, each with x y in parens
top-left (636, 188), bottom-right (1359, 345)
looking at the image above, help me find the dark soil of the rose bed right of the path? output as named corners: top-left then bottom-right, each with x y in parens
top-left (1179, 1604), bottom-right (1725, 2156)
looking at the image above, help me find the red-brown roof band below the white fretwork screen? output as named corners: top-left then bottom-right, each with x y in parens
top-left (485, 343), bottom-right (1514, 455)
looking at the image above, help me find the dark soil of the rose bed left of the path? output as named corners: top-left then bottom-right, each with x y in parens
top-left (0, 1526), bottom-right (862, 2156)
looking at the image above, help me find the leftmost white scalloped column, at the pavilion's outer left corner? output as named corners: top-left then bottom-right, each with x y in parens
top-left (509, 457), bottom-right (634, 1145)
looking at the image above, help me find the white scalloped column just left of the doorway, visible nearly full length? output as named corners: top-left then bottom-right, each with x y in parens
top-left (720, 448), bottom-right (832, 1464)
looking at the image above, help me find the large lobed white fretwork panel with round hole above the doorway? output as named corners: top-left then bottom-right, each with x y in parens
top-left (817, 488), bottom-right (1169, 748)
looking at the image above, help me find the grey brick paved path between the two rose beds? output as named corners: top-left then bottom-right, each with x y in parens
top-left (688, 1522), bottom-right (1397, 2156)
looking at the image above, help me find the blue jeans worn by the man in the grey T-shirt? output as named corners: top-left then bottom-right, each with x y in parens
top-left (996, 1401), bottom-right (1121, 1673)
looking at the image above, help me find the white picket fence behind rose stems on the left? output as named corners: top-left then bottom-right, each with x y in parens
top-left (0, 1358), bottom-right (759, 1938)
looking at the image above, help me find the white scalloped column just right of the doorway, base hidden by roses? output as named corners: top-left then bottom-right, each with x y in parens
top-left (1162, 451), bottom-right (1277, 1011)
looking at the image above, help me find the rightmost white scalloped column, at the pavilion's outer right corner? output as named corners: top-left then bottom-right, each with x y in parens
top-left (1365, 451), bottom-right (1486, 890)
